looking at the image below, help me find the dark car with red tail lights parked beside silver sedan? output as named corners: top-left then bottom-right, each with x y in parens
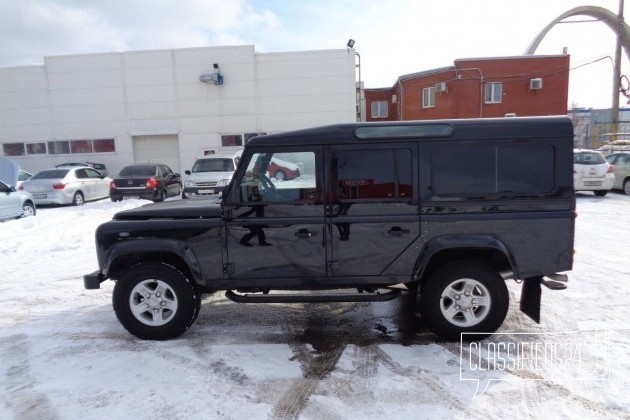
top-left (109, 163), bottom-right (182, 201)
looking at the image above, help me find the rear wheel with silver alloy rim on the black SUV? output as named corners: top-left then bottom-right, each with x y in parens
top-left (418, 261), bottom-right (509, 341)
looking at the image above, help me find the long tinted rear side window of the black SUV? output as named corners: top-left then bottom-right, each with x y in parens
top-left (431, 145), bottom-right (555, 197)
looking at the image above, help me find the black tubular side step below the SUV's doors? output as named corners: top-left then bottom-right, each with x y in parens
top-left (225, 290), bottom-right (400, 303)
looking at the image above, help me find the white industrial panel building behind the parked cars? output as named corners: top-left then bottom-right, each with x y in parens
top-left (0, 46), bottom-right (357, 174)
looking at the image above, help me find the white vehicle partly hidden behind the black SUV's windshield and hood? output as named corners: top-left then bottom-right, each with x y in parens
top-left (182, 151), bottom-right (242, 198)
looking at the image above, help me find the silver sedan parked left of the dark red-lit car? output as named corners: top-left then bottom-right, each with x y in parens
top-left (20, 166), bottom-right (111, 206)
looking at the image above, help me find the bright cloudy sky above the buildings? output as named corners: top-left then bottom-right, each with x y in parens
top-left (0, 0), bottom-right (630, 108)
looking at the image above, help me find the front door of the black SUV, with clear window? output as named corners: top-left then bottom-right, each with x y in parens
top-left (225, 146), bottom-right (326, 286)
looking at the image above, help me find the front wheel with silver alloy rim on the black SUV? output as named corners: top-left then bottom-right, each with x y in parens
top-left (112, 262), bottom-right (201, 340)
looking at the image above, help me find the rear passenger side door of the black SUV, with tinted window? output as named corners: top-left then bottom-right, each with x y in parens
top-left (327, 143), bottom-right (420, 277)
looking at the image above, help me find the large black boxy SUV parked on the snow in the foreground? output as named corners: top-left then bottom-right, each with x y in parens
top-left (84, 117), bottom-right (575, 340)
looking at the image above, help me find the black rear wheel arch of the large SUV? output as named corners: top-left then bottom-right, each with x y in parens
top-left (414, 235), bottom-right (518, 287)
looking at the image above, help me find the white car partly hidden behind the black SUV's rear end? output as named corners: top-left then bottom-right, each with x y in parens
top-left (573, 149), bottom-right (615, 197)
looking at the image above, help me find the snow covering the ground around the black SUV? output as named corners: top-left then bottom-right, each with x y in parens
top-left (0, 193), bottom-right (630, 420)
